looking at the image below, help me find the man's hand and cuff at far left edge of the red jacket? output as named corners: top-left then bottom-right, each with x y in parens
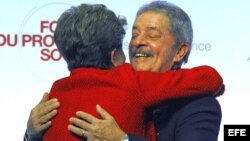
top-left (24, 93), bottom-right (59, 141)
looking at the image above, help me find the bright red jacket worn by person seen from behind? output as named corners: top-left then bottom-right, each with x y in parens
top-left (43, 64), bottom-right (223, 141)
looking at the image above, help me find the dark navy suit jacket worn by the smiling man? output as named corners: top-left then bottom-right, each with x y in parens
top-left (129, 95), bottom-right (222, 141)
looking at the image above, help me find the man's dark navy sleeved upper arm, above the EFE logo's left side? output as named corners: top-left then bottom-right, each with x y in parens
top-left (176, 96), bottom-right (222, 141)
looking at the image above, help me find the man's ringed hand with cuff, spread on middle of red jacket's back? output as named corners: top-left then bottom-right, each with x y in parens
top-left (68, 105), bottom-right (149, 141)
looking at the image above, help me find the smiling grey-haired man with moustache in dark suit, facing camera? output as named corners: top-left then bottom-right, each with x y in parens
top-left (66, 1), bottom-right (221, 141)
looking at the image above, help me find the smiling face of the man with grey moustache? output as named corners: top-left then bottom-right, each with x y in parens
top-left (129, 12), bottom-right (178, 72)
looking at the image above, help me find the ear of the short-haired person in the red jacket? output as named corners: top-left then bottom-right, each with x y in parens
top-left (111, 48), bottom-right (125, 67)
